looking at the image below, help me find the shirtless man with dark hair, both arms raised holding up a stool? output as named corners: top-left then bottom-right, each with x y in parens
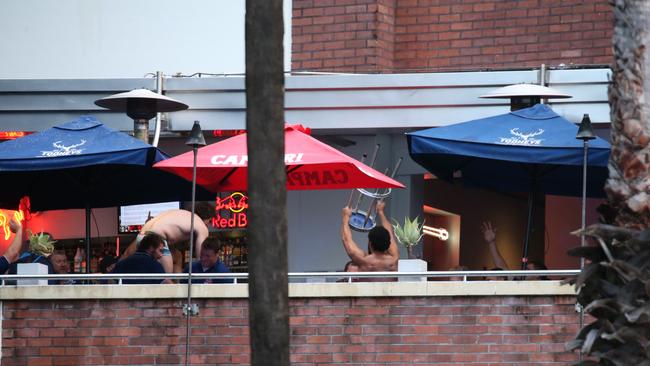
top-left (341, 201), bottom-right (399, 272)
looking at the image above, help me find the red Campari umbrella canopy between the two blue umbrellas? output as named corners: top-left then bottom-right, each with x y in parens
top-left (154, 125), bottom-right (404, 192)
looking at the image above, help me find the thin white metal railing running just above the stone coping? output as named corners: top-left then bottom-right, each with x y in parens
top-left (0, 269), bottom-right (580, 286)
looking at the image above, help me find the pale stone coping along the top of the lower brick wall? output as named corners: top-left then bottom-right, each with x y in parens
top-left (0, 281), bottom-right (576, 300)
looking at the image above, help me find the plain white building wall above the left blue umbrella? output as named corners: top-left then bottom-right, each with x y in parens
top-left (0, 0), bottom-right (292, 79)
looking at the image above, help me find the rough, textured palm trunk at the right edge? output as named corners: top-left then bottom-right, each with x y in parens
top-left (605, 0), bottom-right (650, 229)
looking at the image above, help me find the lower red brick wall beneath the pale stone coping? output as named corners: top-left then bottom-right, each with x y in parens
top-left (1, 296), bottom-right (578, 366)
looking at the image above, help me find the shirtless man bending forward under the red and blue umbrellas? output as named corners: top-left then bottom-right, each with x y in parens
top-left (122, 203), bottom-right (214, 273)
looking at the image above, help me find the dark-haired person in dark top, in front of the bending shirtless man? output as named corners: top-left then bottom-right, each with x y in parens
top-left (112, 232), bottom-right (172, 284)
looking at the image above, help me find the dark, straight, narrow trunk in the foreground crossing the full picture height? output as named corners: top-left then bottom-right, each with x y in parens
top-left (246, 0), bottom-right (289, 366)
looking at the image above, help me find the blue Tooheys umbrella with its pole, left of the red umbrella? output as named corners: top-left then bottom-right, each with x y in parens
top-left (0, 116), bottom-right (213, 268)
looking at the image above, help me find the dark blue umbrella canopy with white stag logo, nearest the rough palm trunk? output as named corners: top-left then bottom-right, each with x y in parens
top-left (407, 104), bottom-right (610, 197)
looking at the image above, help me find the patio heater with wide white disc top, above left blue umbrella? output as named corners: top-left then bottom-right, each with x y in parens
top-left (95, 89), bottom-right (188, 143)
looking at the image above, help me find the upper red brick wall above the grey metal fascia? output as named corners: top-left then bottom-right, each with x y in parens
top-left (292, 0), bottom-right (612, 72)
